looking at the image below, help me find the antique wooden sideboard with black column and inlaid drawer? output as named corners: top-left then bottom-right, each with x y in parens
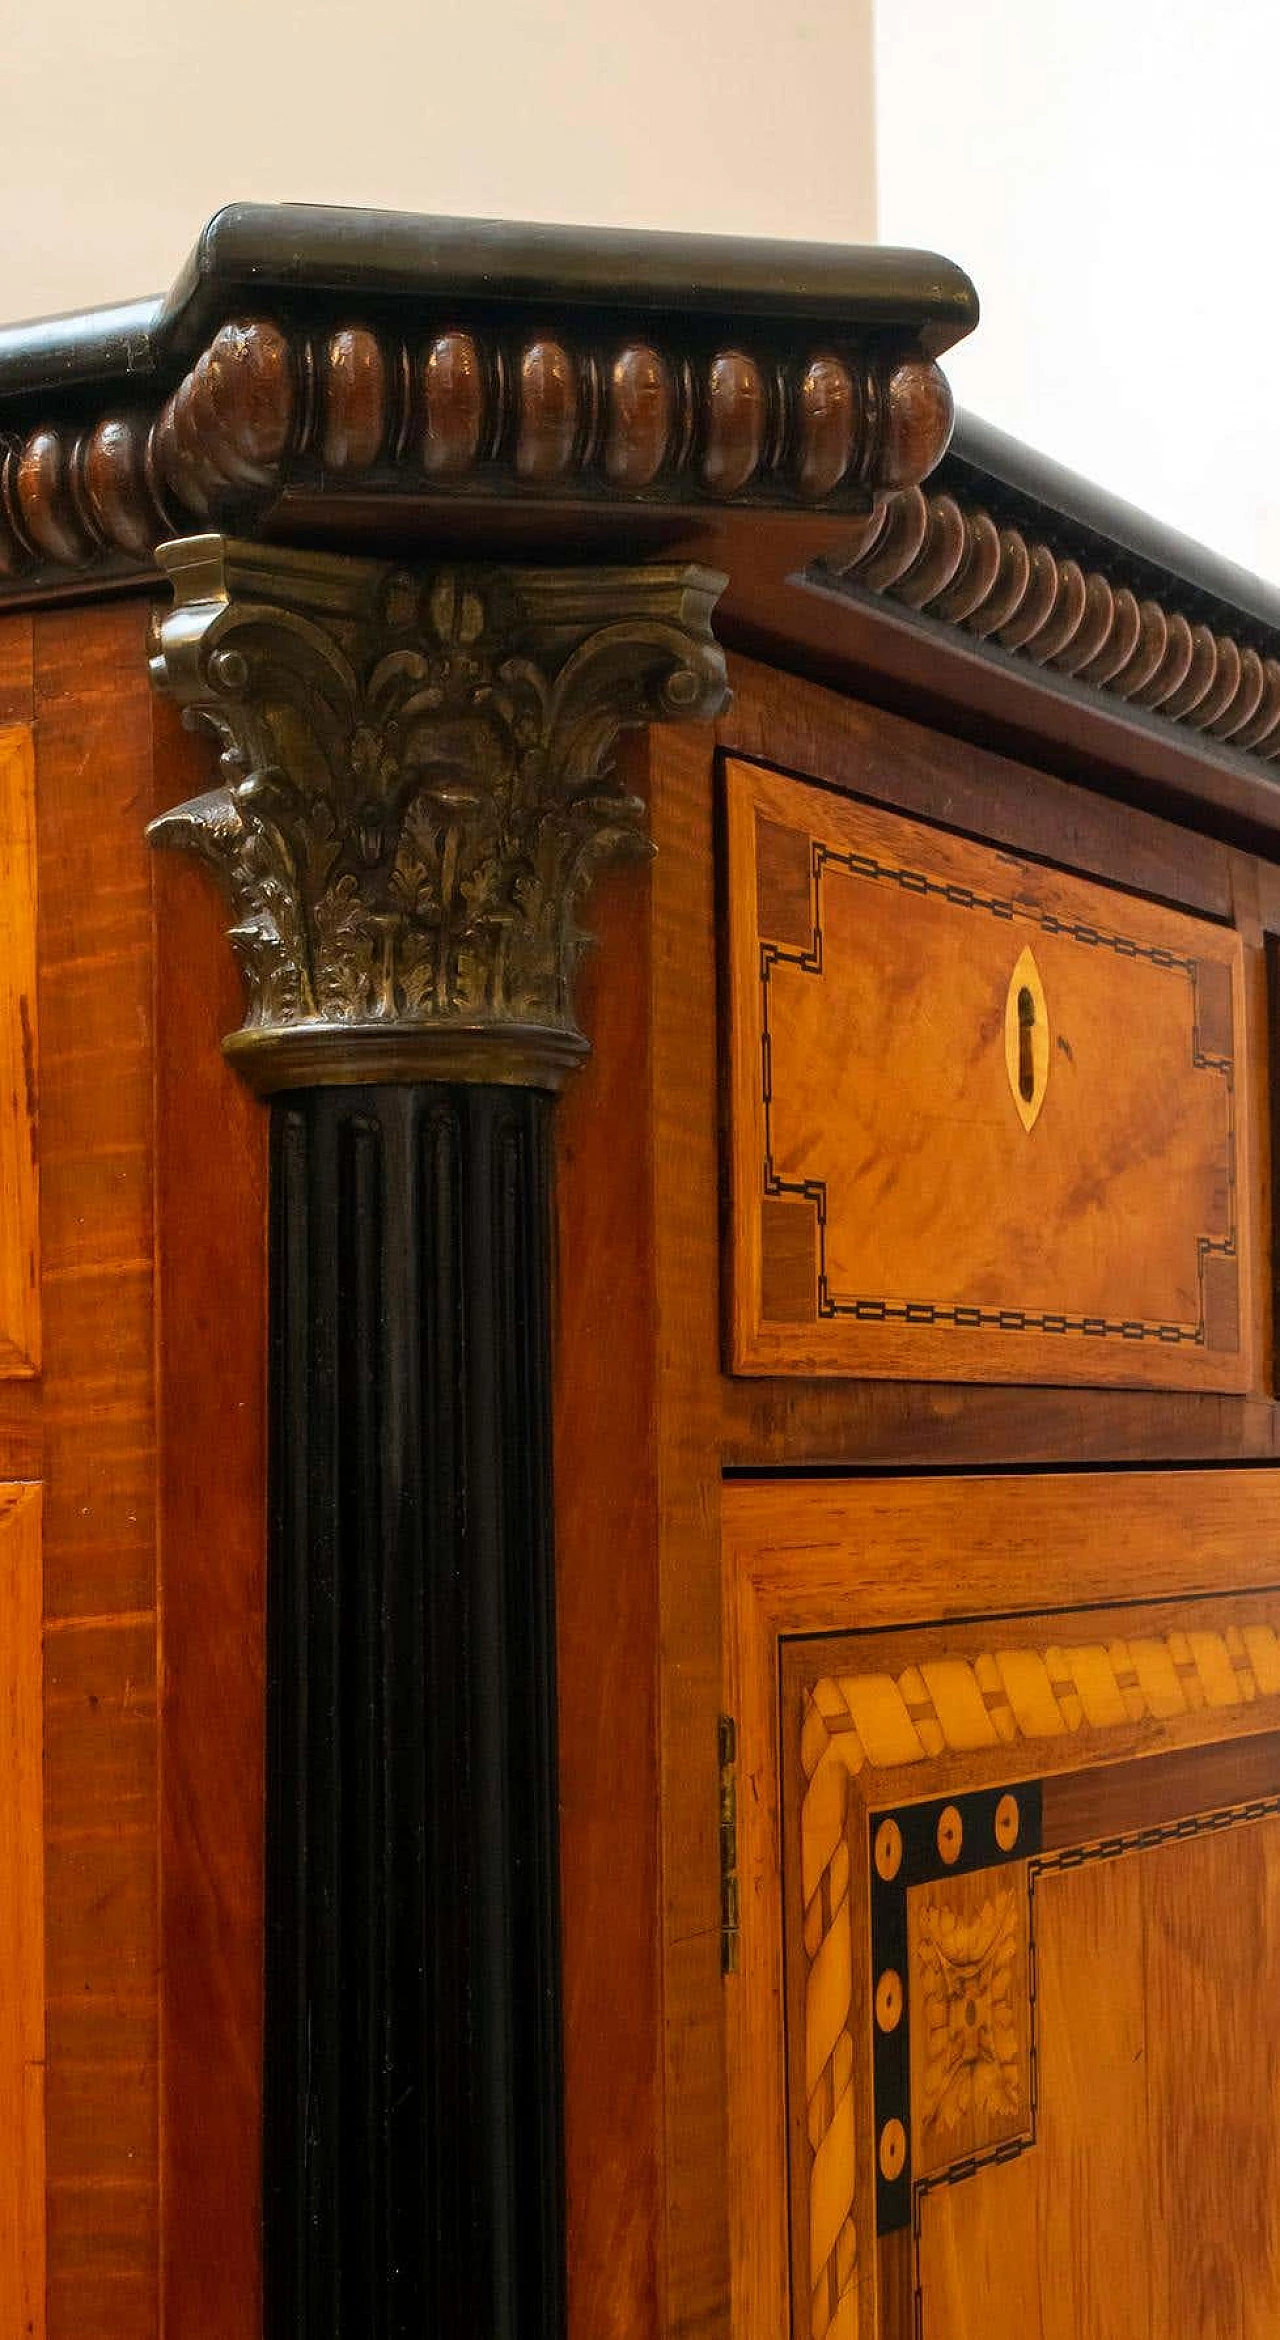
top-left (0, 206), bottom-right (1280, 2340)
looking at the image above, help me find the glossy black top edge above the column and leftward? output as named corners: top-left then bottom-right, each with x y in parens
top-left (0, 204), bottom-right (978, 400)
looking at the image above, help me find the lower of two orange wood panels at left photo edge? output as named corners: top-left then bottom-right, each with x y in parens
top-left (0, 1486), bottom-right (44, 2340)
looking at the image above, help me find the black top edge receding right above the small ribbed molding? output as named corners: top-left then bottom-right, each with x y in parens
top-left (934, 412), bottom-right (1280, 632)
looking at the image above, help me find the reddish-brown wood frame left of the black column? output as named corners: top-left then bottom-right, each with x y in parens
top-left (0, 604), bottom-right (264, 2340)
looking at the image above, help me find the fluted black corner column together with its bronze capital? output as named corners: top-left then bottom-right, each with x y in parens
top-left (152, 536), bottom-right (725, 2340)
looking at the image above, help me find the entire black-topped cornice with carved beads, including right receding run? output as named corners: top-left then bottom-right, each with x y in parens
top-left (12, 204), bottom-right (1280, 786)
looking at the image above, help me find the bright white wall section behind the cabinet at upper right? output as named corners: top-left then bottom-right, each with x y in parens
top-left (875, 0), bottom-right (1280, 580)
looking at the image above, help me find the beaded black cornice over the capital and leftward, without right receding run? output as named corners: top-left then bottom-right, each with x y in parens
top-left (0, 206), bottom-right (976, 599)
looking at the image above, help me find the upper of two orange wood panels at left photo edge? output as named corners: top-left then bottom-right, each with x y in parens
top-left (0, 723), bottom-right (40, 1381)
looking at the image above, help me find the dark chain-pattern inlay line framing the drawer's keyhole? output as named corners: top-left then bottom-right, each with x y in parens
top-left (761, 838), bottom-right (1238, 1348)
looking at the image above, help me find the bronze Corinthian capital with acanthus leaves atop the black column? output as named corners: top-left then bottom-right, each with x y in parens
top-left (150, 536), bottom-right (728, 1090)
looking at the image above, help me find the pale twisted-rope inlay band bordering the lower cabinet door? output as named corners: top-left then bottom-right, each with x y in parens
top-left (800, 1619), bottom-right (1280, 2340)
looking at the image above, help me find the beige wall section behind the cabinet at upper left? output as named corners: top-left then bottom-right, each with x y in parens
top-left (0, 0), bottom-right (875, 321)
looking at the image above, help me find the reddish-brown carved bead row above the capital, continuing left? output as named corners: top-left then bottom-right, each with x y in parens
top-left (0, 318), bottom-right (952, 585)
